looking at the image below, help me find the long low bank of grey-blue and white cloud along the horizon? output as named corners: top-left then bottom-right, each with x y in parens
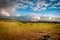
top-left (0, 14), bottom-right (60, 22)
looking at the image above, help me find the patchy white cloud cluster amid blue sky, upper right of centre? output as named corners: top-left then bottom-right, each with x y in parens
top-left (32, 1), bottom-right (51, 11)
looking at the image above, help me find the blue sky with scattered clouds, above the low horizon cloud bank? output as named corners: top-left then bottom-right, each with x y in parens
top-left (0, 0), bottom-right (60, 21)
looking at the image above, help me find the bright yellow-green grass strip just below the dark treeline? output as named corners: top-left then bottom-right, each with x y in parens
top-left (0, 21), bottom-right (60, 30)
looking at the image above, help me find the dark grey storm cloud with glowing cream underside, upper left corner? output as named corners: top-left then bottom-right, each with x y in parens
top-left (0, 0), bottom-right (15, 16)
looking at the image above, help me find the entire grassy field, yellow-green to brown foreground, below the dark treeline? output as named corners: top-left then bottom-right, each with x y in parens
top-left (0, 21), bottom-right (60, 40)
